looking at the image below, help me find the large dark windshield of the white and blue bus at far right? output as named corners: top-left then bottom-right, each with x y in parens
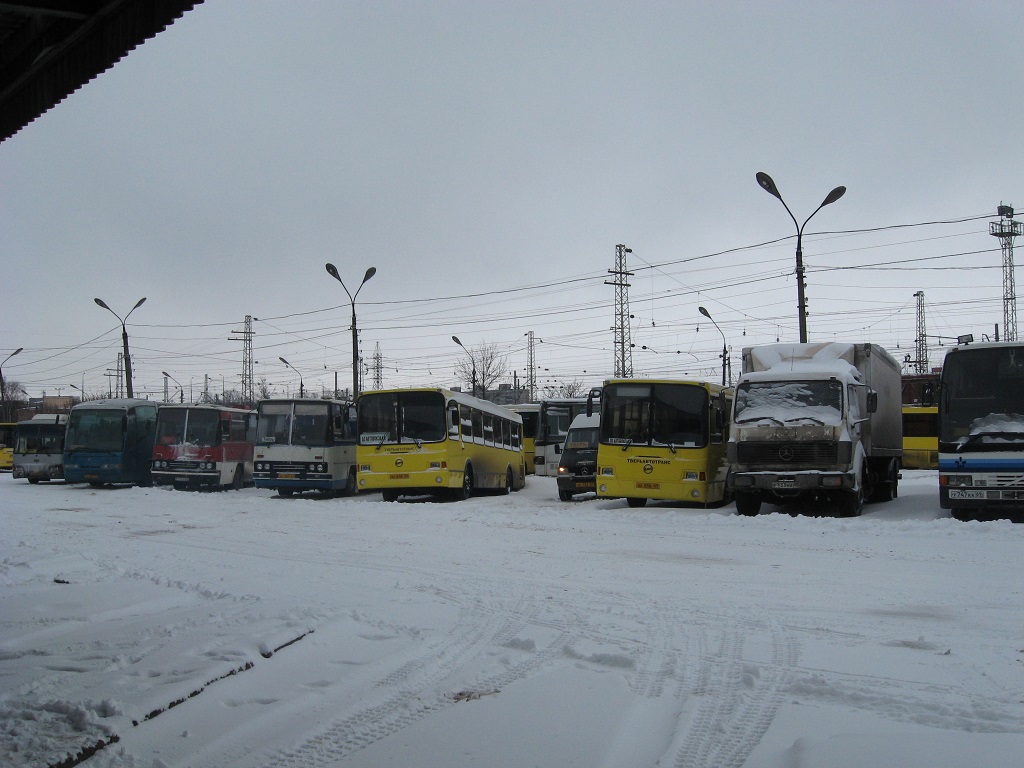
top-left (939, 346), bottom-right (1024, 449)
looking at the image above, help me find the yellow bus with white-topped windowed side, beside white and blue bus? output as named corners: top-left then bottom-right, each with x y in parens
top-left (355, 388), bottom-right (526, 502)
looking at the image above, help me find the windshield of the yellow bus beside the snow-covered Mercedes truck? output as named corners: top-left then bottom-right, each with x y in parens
top-left (601, 384), bottom-right (708, 447)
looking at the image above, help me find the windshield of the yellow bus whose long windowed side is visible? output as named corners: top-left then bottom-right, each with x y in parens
top-left (358, 390), bottom-right (447, 445)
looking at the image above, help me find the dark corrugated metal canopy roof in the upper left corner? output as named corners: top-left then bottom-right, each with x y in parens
top-left (0, 0), bottom-right (203, 141)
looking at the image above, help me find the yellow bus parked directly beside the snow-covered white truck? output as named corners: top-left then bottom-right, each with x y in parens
top-left (597, 379), bottom-right (732, 507)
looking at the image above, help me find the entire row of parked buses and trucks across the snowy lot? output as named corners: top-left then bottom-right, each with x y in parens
top-left (13, 342), bottom-right (1024, 519)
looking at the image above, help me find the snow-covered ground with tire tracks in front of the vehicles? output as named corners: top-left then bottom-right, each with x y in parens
top-left (0, 471), bottom-right (1024, 768)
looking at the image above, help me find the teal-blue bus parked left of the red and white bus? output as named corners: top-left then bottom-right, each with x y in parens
top-left (63, 398), bottom-right (157, 485)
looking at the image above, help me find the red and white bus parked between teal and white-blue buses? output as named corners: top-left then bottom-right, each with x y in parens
top-left (153, 404), bottom-right (256, 488)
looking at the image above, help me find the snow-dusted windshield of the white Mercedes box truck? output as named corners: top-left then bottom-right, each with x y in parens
top-left (735, 379), bottom-right (843, 425)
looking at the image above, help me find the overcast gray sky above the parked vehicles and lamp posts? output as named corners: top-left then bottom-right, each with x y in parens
top-left (0, 0), bottom-right (1024, 397)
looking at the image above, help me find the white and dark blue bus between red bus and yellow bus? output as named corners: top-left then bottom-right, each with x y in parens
top-left (253, 399), bottom-right (355, 496)
